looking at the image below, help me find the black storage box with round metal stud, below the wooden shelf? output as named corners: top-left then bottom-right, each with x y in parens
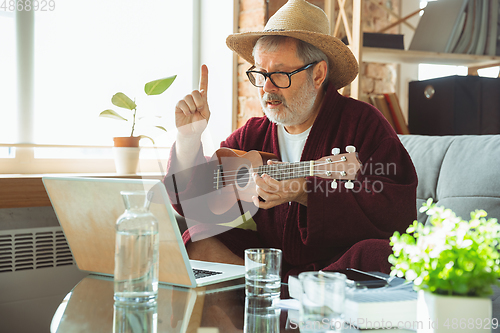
top-left (408, 75), bottom-right (500, 135)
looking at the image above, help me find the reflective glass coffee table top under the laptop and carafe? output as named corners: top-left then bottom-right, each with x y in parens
top-left (50, 275), bottom-right (414, 333)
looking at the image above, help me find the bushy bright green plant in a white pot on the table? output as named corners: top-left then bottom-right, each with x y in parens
top-left (389, 199), bottom-right (500, 332)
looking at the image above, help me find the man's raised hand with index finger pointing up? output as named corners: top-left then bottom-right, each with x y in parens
top-left (175, 65), bottom-right (210, 136)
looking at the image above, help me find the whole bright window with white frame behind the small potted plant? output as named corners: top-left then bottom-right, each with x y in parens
top-left (0, 0), bottom-right (233, 173)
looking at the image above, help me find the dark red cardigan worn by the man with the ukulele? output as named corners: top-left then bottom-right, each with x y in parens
top-left (167, 87), bottom-right (417, 275)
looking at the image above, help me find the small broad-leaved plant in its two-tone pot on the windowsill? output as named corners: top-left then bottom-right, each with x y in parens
top-left (99, 75), bottom-right (177, 174)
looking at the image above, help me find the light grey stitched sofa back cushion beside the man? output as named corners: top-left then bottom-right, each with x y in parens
top-left (400, 135), bottom-right (500, 223)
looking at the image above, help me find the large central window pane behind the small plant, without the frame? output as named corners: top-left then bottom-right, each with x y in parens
top-left (33, 0), bottom-right (193, 145)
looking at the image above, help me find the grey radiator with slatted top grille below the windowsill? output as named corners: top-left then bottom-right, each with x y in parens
top-left (0, 227), bottom-right (88, 333)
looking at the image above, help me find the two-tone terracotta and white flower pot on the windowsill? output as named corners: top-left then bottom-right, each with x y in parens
top-left (113, 136), bottom-right (141, 175)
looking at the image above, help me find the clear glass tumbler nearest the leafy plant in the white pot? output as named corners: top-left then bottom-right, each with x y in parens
top-left (299, 272), bottom-right (346, 332)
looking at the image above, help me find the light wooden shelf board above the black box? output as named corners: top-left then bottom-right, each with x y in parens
top-left (362, 47), bottom-right (500, 68)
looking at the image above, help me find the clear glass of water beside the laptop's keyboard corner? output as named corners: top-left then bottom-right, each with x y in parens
top-left (245, 248), bottom-right (281, 297)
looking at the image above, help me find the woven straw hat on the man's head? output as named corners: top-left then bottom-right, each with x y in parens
top-left (226, 0), bottom-right (358, 89)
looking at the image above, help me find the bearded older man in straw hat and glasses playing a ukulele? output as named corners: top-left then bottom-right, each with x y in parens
top-left (165, 0), bottom-right (417, 279)
